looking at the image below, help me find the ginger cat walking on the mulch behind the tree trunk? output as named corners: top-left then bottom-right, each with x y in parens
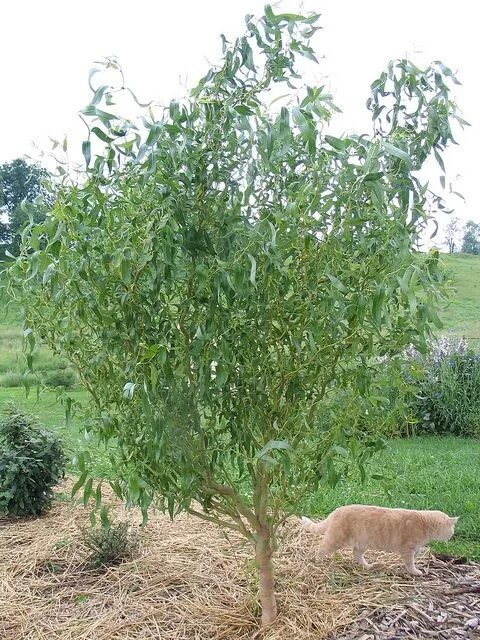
top-left (302, 504), bottom-right (458, 576)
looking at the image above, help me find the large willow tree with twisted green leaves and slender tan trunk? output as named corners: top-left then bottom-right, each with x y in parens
top-left (11, 6), bottom-right (464, 623)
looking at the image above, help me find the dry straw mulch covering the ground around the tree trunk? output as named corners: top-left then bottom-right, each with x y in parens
top-left (0, 482), bottom-right (480, 640)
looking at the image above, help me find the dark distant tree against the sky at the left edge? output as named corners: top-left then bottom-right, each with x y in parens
top-left (0, 158), bottom-right (52, 258)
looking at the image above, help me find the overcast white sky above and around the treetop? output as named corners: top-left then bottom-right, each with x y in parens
top-left (0, 0), bottom-right (480, 246)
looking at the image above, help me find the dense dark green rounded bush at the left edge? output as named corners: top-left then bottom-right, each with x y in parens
top-left (0, 405), bottom-right (65, 516)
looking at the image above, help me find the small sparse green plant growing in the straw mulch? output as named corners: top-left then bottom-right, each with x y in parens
top-left (82, 522), bottom-right (140, 569)
